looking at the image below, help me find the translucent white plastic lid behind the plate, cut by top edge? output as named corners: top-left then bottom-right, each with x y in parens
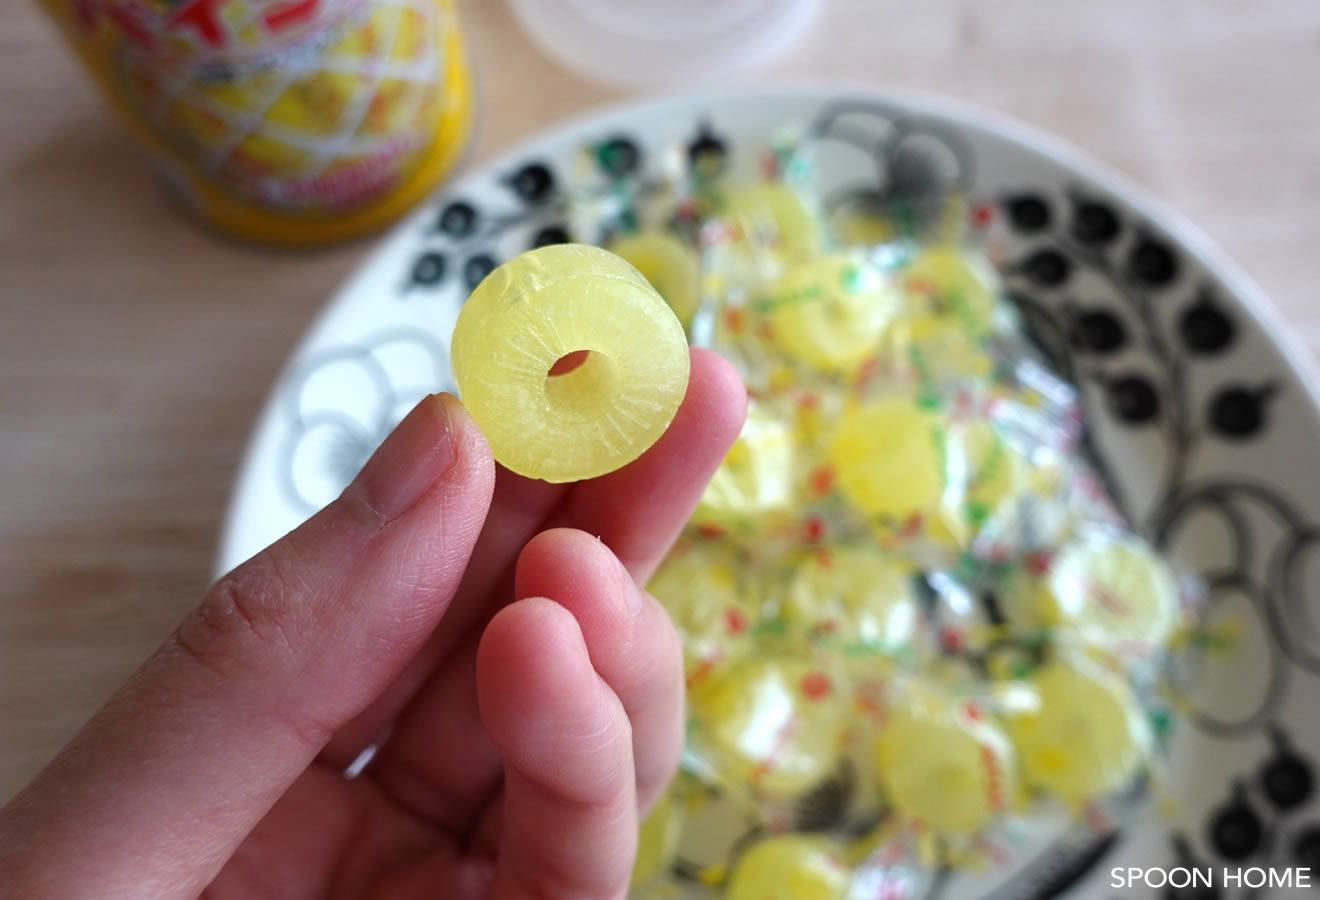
top-left (510, 0), bottom-right (818, 86)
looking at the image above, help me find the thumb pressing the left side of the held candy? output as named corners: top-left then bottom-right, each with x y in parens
top-left (0, 396), bottom-right (495, 900)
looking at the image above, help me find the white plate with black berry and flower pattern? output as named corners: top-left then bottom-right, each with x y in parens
top-left (216, 88), bottom-right (1320, 897)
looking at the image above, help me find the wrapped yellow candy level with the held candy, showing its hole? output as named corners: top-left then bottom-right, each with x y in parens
top-left (756, 253), bottom-right (898, 372)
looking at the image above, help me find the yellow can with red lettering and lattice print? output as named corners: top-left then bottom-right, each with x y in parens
top-left (40, 0), bottom-right (473, 245)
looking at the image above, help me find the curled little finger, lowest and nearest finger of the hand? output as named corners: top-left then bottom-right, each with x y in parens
top-left (477, 598), bottom-right (638, 900)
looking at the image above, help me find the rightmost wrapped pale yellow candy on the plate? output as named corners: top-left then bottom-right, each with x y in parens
top-left (1038, 537), bottom-right (1179, 651)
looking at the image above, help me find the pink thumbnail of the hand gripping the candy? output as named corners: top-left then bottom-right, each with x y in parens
top-left (348, 393), bottom-right (458, 521)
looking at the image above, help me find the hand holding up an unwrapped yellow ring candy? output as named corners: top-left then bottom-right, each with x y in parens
top-left (0, 351), bottom-right (744, 900)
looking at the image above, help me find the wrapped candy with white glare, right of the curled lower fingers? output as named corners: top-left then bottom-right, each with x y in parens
top-left (689, 656), bottom-right (849, 797)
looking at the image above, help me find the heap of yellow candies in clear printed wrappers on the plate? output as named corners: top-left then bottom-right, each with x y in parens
top-left (535, 122), bottom-right (1200, 900)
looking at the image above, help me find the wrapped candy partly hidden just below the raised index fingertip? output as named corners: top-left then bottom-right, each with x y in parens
top-left (693, 401), bottom-right (795, 528)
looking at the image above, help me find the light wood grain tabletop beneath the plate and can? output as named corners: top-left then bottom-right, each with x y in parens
top-left (0, 0), bottom-right (1320, 801)
